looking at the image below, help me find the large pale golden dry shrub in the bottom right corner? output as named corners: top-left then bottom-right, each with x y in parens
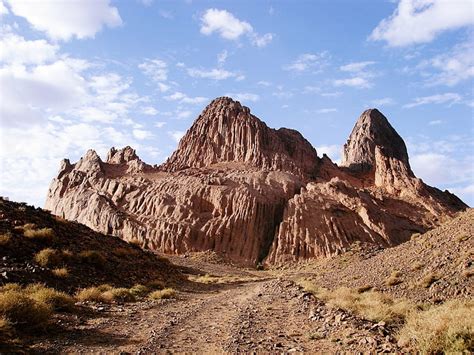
top-left (398, 300), bottom-right (474, 354)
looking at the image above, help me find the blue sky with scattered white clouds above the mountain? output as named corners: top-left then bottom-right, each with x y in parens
top-left (0, 0), bottom-right (474, 206)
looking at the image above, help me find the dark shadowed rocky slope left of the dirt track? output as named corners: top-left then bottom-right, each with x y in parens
top-left (0, 199), bottom-right (180, 292)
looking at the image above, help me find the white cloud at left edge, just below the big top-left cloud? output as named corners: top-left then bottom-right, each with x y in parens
top-left (0, 33), bottom-right (59, 64)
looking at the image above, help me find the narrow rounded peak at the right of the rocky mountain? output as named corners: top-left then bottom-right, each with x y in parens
top-left (341, 108), bottom-right (411, 171)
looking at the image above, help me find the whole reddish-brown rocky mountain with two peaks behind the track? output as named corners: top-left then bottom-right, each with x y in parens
top-left (46, 98), bottom-right (467, 265)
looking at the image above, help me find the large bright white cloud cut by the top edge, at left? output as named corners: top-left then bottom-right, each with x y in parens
top-left (7, 0), bottom-right (122, 41)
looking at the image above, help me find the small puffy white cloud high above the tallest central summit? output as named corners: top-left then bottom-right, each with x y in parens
top-left (201, 9), bottom-right (273, 47)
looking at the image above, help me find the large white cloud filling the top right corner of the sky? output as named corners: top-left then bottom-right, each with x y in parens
top-left (369, 0), bottom-right (474, 47)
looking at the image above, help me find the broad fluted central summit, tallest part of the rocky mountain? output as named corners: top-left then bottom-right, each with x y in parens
top-left (161, 97), bottom-right (318, 176)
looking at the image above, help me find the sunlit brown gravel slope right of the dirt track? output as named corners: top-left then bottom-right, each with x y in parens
top-left (292, 208), bottom-right (474, 303)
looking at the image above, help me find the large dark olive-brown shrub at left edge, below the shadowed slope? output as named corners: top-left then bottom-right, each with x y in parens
top-left (0, 290), bottom-right (52, 329)
